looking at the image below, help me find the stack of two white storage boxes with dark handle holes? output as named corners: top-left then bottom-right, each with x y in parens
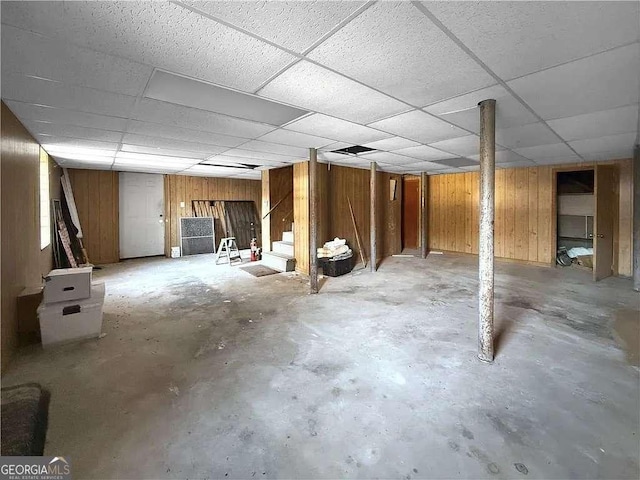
top-left (38, 267), bottom-right (105, 347)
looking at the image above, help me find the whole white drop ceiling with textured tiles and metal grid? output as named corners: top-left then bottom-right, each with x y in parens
top-left (1, 1), bottom-right (640, 178)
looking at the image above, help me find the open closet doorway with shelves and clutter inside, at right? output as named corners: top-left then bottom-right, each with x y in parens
top-left (556, 170), bottom-right (596, 270)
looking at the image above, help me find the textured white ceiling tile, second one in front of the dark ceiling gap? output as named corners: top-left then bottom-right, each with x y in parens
top-left (258, 60), bottom-right (410, 123)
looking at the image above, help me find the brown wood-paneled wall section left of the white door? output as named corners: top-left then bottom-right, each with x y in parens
top-left (67, 169), bottom-right (120, 264)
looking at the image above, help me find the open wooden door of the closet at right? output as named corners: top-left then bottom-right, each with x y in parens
top-left (593, 165), bottom-right (617, 281)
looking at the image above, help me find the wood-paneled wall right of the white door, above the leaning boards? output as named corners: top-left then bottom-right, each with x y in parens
top-left (164, 175), bottom-right (262, 256)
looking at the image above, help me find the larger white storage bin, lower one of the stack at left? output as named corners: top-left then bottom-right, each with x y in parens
top-left (38, 282), bottom-right (105, 347)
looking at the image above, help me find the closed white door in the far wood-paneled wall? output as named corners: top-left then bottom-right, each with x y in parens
top-left (120, 172), bottom-right (164, 258)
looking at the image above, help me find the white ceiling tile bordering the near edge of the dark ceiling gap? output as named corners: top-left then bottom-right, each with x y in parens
top-left (286, 114), bottom-right (393, 145)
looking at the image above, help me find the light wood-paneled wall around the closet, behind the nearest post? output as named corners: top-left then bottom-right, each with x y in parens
top-left (428, 160), bottom-right (632, 275)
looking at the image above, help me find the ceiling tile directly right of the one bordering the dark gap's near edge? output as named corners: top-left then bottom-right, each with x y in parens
top-left (369, 110), bottom-right (467, 143)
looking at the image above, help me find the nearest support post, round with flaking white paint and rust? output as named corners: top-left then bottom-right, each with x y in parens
top-left (478, 99), bottom-right (496, 362)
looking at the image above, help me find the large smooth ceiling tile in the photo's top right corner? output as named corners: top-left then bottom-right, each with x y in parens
top-left (424, 2), bottom-right (640, 79)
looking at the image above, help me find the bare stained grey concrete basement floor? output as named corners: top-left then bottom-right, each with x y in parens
top-left (3, 255), bottom-right (640, 479)
